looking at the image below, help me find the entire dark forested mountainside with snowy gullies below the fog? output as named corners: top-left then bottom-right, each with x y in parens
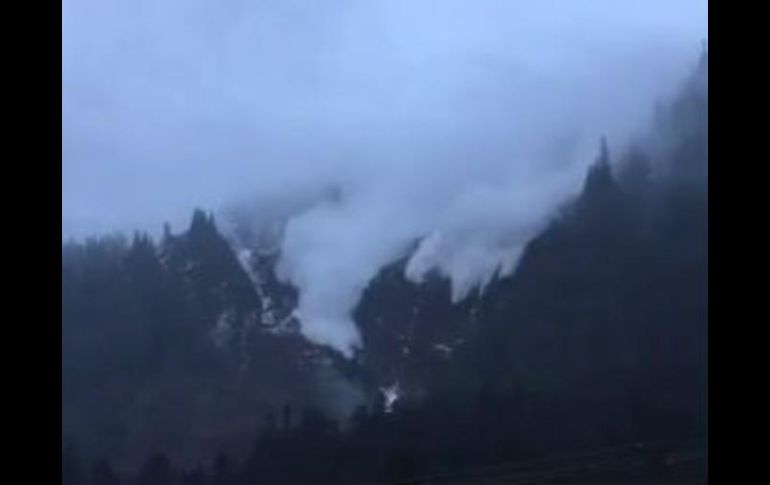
top-left (62, 53), bottom-right (708, 483)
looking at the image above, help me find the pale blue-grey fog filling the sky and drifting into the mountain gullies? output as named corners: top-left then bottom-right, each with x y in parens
top-left (62, 0), bottom-right (707, 355)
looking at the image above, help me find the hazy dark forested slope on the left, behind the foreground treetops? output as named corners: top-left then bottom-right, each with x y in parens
top-left (62, 211), bottom-right (316, 476)
